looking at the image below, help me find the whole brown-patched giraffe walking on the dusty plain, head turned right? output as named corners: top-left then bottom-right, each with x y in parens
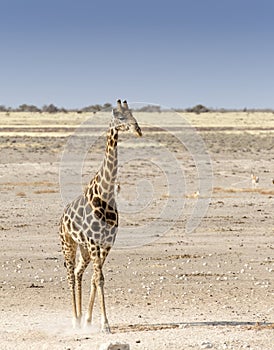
top-left (59, 100), bottom-right (142, 333)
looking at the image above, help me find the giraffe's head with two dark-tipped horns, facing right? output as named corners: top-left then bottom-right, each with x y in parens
top-left (112, 100), bottom-right (142, 136)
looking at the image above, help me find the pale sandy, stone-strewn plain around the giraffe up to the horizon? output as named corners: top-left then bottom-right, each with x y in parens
top-left (0, 112), bottom-right (274, 350)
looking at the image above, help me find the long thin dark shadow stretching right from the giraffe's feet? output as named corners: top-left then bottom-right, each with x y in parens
top-left (111, 321), bottom-right (274, 333)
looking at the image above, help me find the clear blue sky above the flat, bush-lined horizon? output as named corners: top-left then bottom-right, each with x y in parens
top-left (0, 0), bottom-right (274, 108)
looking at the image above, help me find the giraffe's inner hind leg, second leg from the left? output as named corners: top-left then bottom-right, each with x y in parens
top-left (75, 245), bottom-right (91, 321)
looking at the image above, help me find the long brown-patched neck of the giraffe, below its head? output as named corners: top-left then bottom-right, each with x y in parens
top-left (87, 124), bottom-right (118, 202)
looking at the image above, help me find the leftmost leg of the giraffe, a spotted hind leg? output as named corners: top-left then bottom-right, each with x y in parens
top-left (60, 230), bottom-right (80, 327)
